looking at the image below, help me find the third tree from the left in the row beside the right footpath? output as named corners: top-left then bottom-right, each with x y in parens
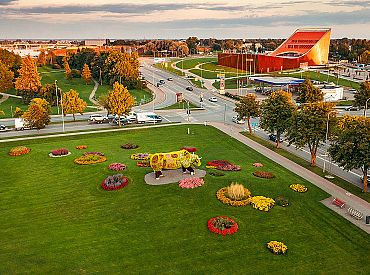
top-left (286, 102), bottom-right (335, 167)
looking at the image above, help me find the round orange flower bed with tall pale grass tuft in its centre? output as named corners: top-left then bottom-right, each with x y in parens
top-left (216, 184), bottom-right (251, 206)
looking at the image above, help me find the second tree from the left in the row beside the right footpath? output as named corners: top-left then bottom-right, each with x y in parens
top-left (260, 91), bottom-right (296, 148)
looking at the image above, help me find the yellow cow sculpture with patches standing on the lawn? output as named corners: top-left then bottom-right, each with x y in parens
top-left (150, 150), bottom-right (201, 179)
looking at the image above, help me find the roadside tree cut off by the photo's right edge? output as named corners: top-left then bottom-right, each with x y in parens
top-left (329, 115), bottom-right (370, 192)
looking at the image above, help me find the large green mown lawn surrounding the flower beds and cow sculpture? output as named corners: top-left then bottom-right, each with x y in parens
top-left (0, 125), bottom-right (370, 274)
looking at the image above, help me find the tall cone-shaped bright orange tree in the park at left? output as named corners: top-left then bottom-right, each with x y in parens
top-left (15, 55), bottom-right (41, 103)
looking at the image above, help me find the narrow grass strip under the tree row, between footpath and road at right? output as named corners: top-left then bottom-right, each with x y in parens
top-left (243, 132), bottom-right (370, 202)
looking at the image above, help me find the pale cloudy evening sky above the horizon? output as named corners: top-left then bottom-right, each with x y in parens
top-left (0, 0), bottom-right (370, 39)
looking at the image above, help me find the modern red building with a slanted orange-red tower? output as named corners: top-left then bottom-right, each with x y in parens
top-left (218, 28), bottom-right (331, 73)
